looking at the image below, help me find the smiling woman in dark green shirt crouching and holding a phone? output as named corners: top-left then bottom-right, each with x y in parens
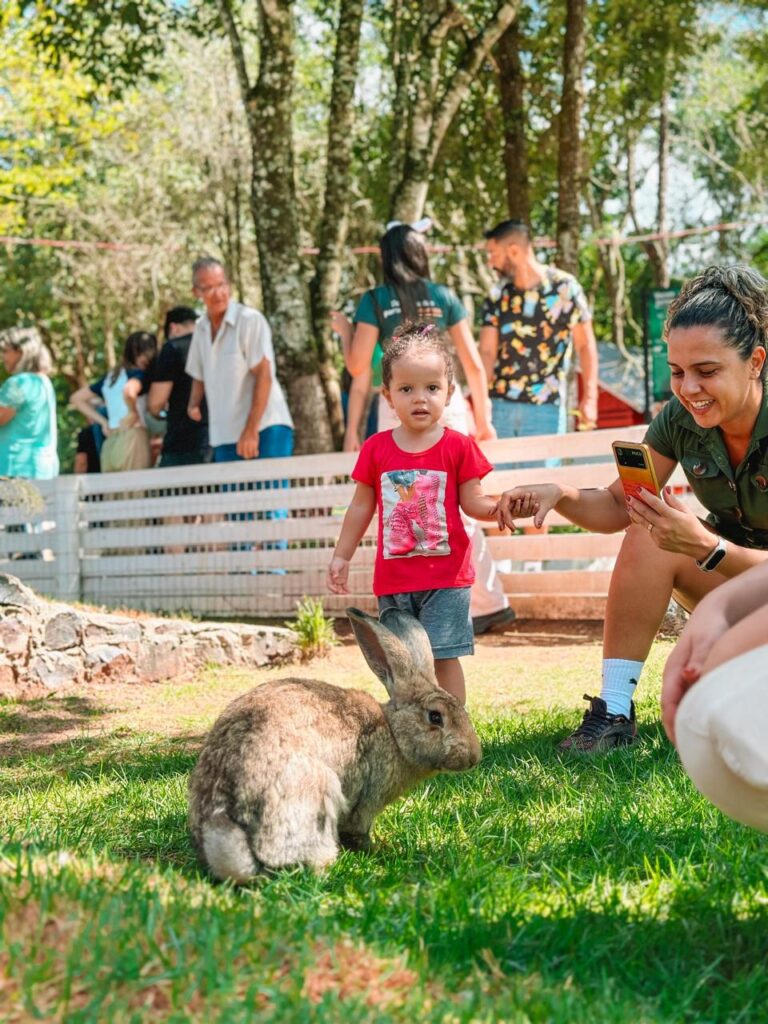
top-left (501, 266), bottom-right (768, 754)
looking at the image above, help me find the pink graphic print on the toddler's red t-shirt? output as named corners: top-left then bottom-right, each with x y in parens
top-left (381, 469), bottom-right (451, 558)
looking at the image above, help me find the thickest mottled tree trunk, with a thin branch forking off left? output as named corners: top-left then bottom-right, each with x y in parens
top-left (216, 0), bottom-right (333, 455)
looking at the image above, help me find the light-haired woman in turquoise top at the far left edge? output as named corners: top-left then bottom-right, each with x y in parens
top-left (0, 328), bottom-right (58, 480)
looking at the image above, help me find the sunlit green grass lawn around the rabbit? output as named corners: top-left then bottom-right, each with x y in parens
top-left (0, 643), bottom-right (768, 1024)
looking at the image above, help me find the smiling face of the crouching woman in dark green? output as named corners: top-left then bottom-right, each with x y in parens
top-left (667, 327), bottom-right (766, 433)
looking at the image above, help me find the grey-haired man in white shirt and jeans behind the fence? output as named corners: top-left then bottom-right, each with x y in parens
top-left (186, 256), bottom-right (294, 462)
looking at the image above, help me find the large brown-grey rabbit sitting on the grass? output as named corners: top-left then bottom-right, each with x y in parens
top-left (189, 608), bottom-right (481, 882)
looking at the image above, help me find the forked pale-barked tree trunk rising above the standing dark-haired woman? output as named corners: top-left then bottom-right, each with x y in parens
top-left (390, 0), bottom-right (519, 221)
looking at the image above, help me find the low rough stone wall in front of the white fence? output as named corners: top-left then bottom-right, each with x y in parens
top-left (0, 573), bottom-right (295, 698)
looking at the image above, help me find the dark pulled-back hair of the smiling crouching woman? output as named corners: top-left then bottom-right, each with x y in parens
top-left (665, 266), bottom-right (768, 369)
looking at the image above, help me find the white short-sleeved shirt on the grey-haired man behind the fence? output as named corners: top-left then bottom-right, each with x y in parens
top-left (186, 299), bottom-right (293, 446)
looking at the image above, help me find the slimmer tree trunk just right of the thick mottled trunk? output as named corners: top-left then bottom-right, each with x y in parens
top-left (310, 0), bottom-right (365, 447)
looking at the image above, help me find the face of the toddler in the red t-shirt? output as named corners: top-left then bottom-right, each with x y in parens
top-left (382, 351), bottom-right (454, 433)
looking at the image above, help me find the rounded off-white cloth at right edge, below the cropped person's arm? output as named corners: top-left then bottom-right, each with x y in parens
top-left (675, 646), bottom-right (768, 831)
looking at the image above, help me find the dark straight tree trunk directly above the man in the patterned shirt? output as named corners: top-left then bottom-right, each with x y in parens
top-left (496, 18), bottom-right (530, 224)
